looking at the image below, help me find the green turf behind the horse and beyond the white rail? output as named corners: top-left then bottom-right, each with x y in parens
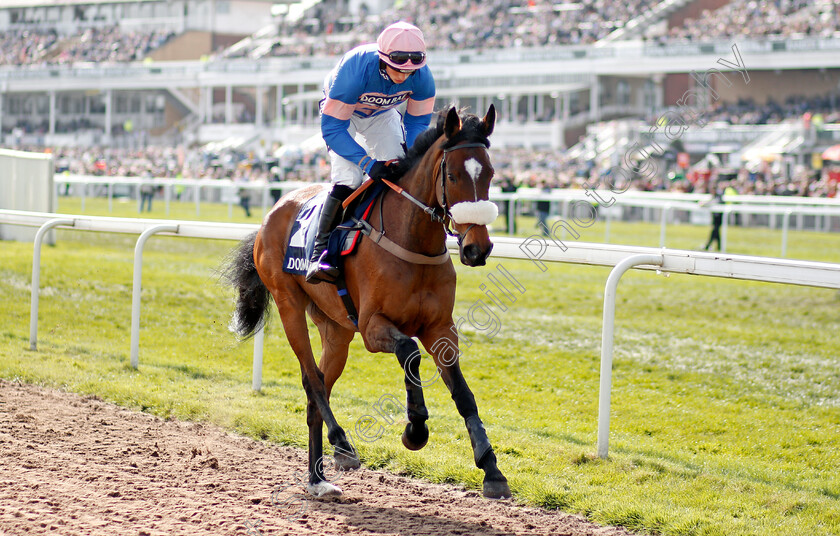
top-left (0, 198), bottom-right (840, 536)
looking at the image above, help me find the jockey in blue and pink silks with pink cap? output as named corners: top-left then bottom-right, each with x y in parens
top-left (306, 22), bottom-right (435, 283)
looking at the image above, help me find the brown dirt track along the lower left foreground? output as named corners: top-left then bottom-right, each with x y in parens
top-left (0, 380), bottom-right (629, 536)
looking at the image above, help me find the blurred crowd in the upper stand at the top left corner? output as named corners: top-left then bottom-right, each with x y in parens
top-left (0, 26), bottom-right (175, 65)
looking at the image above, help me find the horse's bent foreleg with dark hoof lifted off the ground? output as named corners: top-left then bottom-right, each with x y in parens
top-left (365, 316), bottom-right (429, 450)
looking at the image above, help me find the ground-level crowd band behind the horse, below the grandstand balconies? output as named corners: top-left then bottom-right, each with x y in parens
top-left (29, 141), bottom-right (840, 197)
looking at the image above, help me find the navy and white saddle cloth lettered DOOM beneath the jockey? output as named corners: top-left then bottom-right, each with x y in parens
top-left (283, 182), bottom-right (385, 275)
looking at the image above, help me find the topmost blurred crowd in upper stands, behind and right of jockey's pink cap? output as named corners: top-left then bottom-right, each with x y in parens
top-left (221, 0), bottom-right (840, 57)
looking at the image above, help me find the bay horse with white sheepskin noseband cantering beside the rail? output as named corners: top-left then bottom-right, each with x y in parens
top-left (225, 105), bottom-right (511, 498)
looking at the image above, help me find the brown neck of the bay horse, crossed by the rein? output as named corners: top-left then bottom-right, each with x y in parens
top-left (382, 147), bottom-right (446, 255)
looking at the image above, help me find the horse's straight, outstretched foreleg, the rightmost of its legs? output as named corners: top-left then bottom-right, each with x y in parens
top-left (420, 327), bottom-right (511, 499)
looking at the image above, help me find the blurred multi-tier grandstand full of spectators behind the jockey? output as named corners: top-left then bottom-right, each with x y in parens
top-left (0, 0), bottom-right (840, 199)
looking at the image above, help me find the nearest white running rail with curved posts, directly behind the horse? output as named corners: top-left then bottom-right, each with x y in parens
top-left (0, 210), bottom-right (840, 458)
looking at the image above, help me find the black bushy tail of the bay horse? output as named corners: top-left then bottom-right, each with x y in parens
top-left (221, 232), bottom-right (271, 340)
